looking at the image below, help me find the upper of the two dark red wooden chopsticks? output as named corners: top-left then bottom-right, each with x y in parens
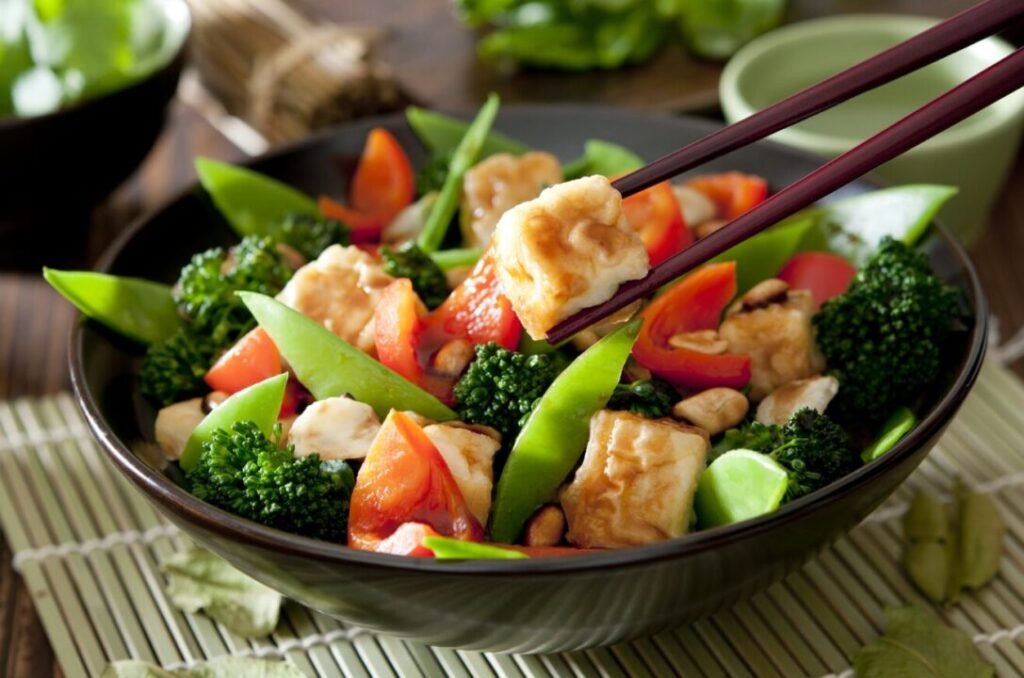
top-left (613, 0), bottom-right (1024, 197)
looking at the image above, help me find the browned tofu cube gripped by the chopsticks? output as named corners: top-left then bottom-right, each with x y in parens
top-left (493, 176), bottom-right (649, 339)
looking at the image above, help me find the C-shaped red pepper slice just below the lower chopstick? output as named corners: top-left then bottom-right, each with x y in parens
top-left (633, 261), bottom-right (751, 389)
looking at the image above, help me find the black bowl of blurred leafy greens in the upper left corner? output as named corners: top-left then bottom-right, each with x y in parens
top-left (0, 0), bottom-right (190, 235)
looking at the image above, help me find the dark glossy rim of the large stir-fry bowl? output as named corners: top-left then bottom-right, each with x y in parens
top-left (68, 104), bottom-right (988, 577)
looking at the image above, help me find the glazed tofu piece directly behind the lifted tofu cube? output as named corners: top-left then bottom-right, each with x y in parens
top-left (462, 151), bottom-right (562, 248)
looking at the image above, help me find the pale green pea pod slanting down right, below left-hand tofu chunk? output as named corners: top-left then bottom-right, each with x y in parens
top-left (239, 292), bottom-right (456, 421)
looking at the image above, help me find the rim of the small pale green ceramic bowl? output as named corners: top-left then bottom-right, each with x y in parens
top-left (719, 13), bottom-right (1024, 157)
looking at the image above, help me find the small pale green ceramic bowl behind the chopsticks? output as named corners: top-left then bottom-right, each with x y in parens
top-left (720, 14), bottom-right (1024, 242)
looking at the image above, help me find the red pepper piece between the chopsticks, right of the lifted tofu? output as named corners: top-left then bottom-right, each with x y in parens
top-left (623, 181), bottom-right (693, 266)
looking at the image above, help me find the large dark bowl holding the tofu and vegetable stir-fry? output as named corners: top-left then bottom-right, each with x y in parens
top-left (71, 108), bottom-right (986, 652)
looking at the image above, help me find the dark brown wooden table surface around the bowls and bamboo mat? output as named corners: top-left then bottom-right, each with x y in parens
top-left (0, 0), bottom-right (1024, 677)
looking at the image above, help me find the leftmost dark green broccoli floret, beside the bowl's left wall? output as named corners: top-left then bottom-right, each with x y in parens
top-left (139, 328), bottom-right (217, 405)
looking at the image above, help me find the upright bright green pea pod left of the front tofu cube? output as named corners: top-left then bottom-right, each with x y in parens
top-left (490, 319), bottom-right (641, 544)
